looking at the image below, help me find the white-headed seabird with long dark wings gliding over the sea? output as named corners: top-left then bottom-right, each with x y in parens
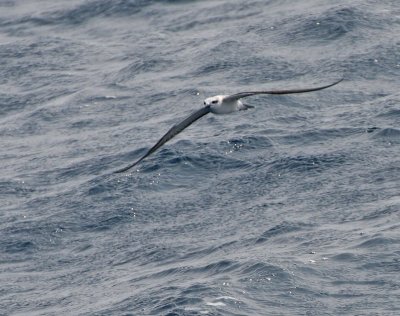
top-left (115, 79), bottom-right (343, 173)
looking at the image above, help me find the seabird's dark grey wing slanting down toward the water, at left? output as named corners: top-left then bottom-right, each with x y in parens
top-left (114, 106), bottom-right (210, 173)
